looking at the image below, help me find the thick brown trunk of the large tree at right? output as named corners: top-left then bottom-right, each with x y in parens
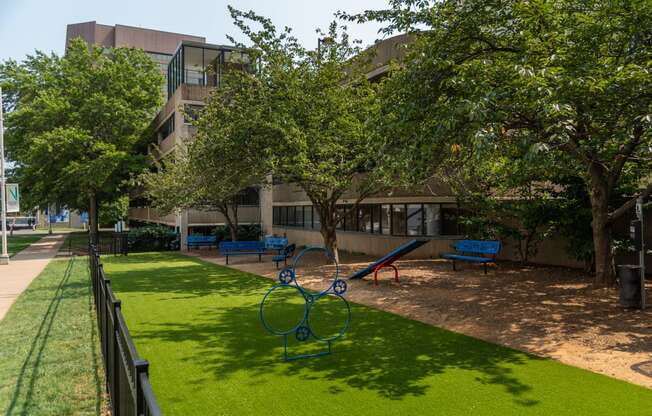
top-left (590, 169), bottom-right (616, 287)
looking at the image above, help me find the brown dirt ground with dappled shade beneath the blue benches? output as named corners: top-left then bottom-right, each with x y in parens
top-left (185, 250), bottom-right (652, 389)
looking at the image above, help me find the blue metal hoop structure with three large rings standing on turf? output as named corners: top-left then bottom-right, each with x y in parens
top-left (260, 246), bottom-right (351, 361)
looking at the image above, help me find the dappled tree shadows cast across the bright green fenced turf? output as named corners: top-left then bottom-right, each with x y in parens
top-left (108, 255), bottom-right (538, 406)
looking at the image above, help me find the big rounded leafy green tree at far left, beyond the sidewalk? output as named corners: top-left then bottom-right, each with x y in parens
top-left (0, 39), bottom-right (163, 240)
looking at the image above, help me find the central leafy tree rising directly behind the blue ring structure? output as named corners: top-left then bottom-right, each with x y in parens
top-left (228, 8), bottom-right (378, 259)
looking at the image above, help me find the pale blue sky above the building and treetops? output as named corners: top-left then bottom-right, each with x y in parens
top-left (0, 0), bottom-right (387, 60)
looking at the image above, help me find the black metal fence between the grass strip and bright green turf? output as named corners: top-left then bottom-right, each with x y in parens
top-left (88, 245), bottom-right (161, 416)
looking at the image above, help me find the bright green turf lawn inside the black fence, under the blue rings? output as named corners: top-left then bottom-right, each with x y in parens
top-left (104, 253), bottom-right (652, 416)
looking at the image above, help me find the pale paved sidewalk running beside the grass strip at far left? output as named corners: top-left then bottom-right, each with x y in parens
top-left (0, 235), bottom-right (65, 321)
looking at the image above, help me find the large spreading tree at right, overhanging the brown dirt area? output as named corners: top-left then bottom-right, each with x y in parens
top-left (344, 0), bottom-right (652, 286)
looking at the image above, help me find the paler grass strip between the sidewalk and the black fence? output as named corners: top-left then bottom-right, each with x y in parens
top-left (0, 258), bottom-right (106, 416)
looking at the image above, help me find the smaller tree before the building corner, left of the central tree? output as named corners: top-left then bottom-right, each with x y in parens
top-left (141, 70), bottom-right (271, 241)
